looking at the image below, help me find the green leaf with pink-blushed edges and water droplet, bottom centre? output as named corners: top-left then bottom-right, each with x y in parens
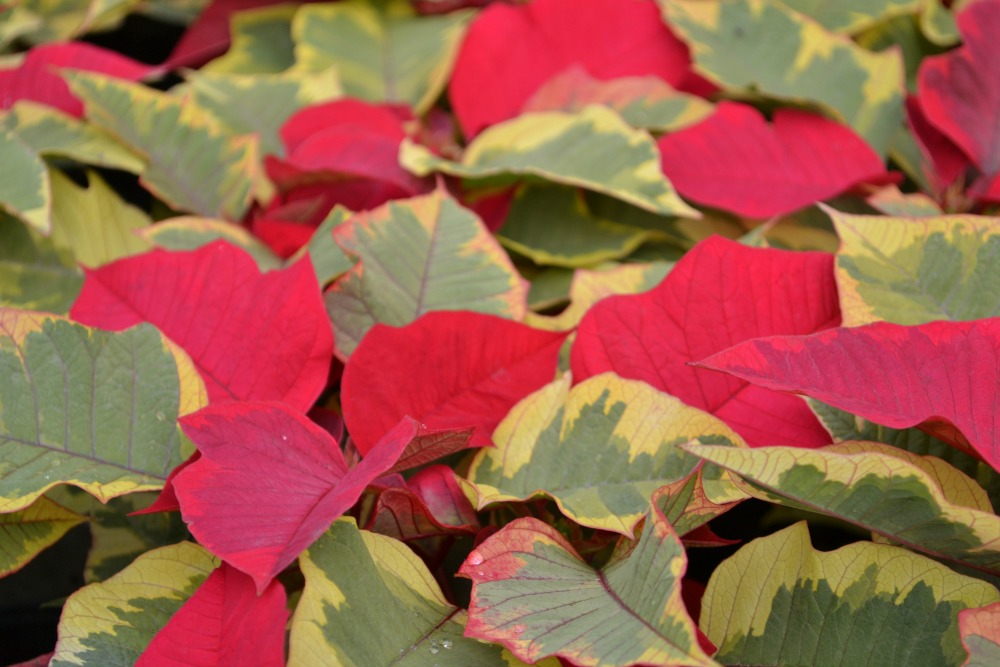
top-left (459, 490), bottom-right (716, 667)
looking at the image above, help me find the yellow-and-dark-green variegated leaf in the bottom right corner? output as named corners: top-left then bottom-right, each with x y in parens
top-left (700, 522), bottom-right (1000, 667)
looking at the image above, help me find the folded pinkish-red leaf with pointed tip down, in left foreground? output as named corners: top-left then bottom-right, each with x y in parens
top-left (174, 403), bottom-right (410, 593)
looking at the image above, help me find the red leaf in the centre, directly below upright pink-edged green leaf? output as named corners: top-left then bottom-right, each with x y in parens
top-left (341, 311), bottom-right (566, 454)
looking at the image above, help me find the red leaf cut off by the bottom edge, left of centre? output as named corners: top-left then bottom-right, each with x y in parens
top-left (135, 563), bottom-right (288, 667)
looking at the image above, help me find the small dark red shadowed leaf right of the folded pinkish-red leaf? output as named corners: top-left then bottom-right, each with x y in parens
top-left (367, 465), bottom-right (479, 540)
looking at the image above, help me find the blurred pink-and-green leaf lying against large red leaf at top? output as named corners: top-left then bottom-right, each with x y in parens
top-left (521, 65), bottom-right (712, 132)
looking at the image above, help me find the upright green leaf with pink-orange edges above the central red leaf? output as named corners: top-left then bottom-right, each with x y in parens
top-left (324, 189), bottom-right (527, 359)
